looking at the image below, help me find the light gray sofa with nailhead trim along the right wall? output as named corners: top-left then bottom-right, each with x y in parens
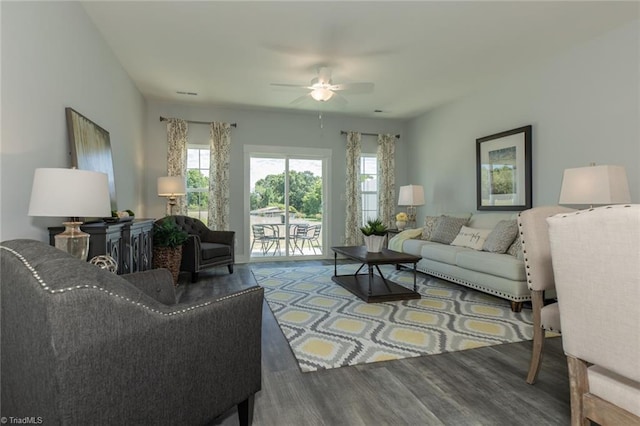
top-left (389, 213), bottom-right (531, 312)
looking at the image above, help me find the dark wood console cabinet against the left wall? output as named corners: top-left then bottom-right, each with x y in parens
top-left (49, 219), bottom-right (154, 274)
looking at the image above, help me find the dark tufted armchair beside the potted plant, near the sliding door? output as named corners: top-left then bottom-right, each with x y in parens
top-left (158, 215), bottom-right (236, 282)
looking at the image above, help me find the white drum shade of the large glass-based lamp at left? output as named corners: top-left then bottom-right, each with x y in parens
top-left (29, 169), bottom-right (111, 217)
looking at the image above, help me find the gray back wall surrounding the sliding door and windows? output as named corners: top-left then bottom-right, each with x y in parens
top-left (144, 101), bottom-right (409, 261)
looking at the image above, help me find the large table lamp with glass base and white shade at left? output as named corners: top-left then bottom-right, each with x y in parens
top-left (29, 168), bottom-right (111, 260)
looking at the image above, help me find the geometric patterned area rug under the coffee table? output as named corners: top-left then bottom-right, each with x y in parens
top-left (253, 264), bottom-right (533, 372)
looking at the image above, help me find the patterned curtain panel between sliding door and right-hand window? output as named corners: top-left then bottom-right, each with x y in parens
top-left (345, 132), bottom-right (363, 246)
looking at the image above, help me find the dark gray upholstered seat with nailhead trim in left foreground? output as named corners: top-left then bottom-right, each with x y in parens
top-left (0, 240), bottom-right (263, 425)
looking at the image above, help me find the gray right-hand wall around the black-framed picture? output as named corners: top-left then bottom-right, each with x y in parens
top-left (406, 21), bottom-right (640, 217)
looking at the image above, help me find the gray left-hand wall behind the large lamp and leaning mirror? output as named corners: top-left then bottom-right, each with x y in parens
top-left (0, 2), bottom-right (145, 241)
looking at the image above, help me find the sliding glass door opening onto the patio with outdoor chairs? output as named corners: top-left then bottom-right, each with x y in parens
top-left (249, 146), bottom-right (327, 260)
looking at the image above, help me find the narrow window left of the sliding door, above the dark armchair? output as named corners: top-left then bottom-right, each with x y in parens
top-left (187, 146), bottom-right (210, 223)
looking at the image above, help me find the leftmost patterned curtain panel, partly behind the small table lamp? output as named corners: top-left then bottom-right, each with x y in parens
top-left (167, 118), bottom-right (188, 215)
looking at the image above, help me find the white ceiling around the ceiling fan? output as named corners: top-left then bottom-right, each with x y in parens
top-left (82, 1), bottom-right (639, 119)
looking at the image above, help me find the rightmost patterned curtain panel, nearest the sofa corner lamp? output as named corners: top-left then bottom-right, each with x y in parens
top-left (377, 134), bottom-right (396, 227)
